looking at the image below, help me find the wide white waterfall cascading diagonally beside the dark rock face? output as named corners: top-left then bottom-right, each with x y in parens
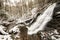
top-left (27, 3), bottom-right (56, 35)
